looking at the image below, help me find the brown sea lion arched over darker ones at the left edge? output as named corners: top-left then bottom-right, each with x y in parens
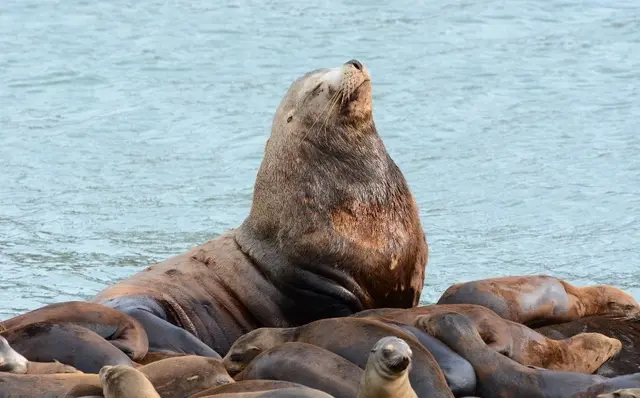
top-left (0, 301), bottom-right (149, 361)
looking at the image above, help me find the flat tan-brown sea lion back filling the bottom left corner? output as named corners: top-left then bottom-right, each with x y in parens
top-left (0, 372), bottom-right (102, 398)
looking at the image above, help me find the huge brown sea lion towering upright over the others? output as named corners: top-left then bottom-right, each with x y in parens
top-left (82, 60), bottom-right (428, 357)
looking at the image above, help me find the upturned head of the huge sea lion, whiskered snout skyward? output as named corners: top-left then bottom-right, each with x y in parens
top-left (274, 60), bottom-right (372, 138)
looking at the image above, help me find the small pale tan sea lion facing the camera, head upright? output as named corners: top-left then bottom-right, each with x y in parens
top-left (357, 337), bottom-right (418, 398)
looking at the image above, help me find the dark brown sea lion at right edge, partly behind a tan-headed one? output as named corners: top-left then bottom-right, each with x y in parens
top-left (536, 316), bottom-right (640, 377)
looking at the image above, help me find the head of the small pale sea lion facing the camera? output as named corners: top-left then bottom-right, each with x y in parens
top-left (367, 336), bottom-right (413, 379)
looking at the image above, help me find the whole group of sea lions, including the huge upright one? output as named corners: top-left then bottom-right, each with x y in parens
top-left (0, 60), bottom-right (640, 398)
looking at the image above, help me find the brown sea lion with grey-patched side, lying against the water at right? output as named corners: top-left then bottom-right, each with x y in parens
top-left (438, 275), bottom-right (640, 327)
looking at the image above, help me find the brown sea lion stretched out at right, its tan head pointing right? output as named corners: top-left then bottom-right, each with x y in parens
top-left (354, 304), bottom-right (622, 374)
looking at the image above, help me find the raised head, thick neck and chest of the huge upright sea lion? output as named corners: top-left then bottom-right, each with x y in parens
top-left (235, 60), bottom-right (427, 326)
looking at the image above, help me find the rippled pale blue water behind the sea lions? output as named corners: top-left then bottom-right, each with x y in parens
top-left (0, 0), bottom-right (640, 319)
